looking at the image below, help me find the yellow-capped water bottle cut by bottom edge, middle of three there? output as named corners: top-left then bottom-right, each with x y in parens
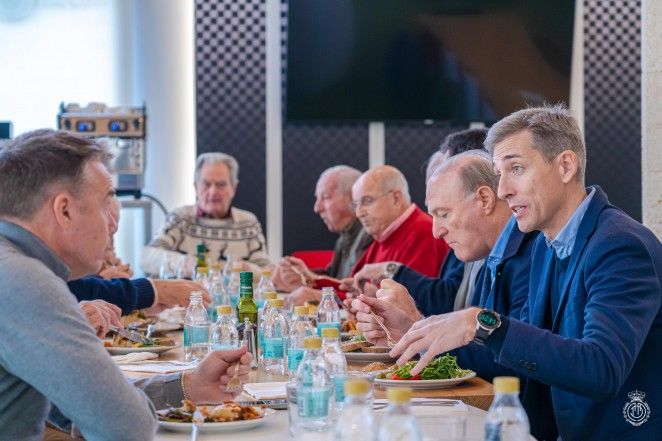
top-left (377, 387), bottom-right (423, 441)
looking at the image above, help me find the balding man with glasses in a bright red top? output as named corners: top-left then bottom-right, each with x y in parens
top-left (343, 165), bottom-right (448, 287)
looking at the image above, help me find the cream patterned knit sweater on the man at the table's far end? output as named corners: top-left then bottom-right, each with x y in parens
top-left (140, 205), bottom-right (270, 274)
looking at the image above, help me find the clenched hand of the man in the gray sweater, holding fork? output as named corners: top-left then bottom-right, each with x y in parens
top-left (184, 346), bottom-right (253, 404)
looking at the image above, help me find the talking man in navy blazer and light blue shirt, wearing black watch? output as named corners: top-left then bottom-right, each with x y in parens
top-left (391, 106), bottom-right (662, 440)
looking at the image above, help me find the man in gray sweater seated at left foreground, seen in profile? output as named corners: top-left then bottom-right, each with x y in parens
top-left (0, 130), bottom-right (250, 441)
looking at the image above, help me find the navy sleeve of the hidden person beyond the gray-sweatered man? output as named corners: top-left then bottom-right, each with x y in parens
top-left (67, 276), bottom-right (154, 315)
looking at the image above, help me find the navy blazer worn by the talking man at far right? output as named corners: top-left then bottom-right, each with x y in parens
top-left (488, 187), bottom-right (662, 441)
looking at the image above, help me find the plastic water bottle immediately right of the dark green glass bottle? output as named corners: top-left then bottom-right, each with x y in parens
top-left (262, 299), bottom-right (290, 375)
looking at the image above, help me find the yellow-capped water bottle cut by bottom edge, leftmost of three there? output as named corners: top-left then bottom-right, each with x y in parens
top-left (334, 378), bottom-right (376, 441)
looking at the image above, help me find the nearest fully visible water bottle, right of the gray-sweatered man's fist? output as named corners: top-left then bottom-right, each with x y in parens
top-left (296, 337), bottom-right (334, 432)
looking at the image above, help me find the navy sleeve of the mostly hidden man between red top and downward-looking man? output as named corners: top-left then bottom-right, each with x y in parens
top-left (393, 250), bottom-right (464, 317)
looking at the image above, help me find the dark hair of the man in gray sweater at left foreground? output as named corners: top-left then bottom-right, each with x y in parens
top-left (0, 129), bottom-right (112, 220)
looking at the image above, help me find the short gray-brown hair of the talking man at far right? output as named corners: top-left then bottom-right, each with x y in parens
top-left (485, 104), bottom-right (586, 183)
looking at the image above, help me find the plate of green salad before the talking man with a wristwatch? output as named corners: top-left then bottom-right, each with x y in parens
top-left (375, 354), bottom-right (476, 389)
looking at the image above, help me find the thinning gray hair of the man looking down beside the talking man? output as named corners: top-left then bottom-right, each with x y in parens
top-left (430, 150), bottom-right (499, 196)
